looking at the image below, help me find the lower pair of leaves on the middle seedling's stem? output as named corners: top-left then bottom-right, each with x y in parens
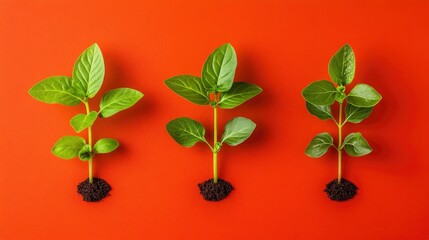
top-left (167, 117), bottom-right (256, 147)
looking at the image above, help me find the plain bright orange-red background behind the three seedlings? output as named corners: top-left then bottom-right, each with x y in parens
top-left (0, 0), bottom-right (429, 239)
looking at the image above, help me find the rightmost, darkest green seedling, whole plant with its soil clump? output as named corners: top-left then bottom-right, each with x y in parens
top-left (302, 44), bottom-right (381, 201)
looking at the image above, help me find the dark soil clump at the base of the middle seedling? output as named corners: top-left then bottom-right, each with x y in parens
top-left (198, 178), bottom-right (234, 202)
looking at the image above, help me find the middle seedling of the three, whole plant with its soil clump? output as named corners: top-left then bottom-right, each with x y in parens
top-left (165, 44), bottom-right (262, 201)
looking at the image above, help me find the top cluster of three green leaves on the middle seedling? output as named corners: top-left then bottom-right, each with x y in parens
top-left (165, 44), bottom-right (262, 109)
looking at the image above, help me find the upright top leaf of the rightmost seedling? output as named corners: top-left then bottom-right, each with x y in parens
top-left (328, 44), bottom-right (356, 85)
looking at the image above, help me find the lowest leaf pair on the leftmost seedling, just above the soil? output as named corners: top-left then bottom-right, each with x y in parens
top-left (52, 136), bottom-right (119, 161)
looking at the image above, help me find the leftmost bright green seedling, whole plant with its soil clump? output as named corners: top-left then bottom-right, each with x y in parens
top-left (29, 44), bottom-right (143, 202)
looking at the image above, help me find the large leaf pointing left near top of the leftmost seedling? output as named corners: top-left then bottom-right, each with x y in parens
top-left (28, 76), bottom-right (82, 106)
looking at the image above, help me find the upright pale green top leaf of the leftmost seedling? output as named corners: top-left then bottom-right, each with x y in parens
top-left (73, 43), bottom-right (104, 98)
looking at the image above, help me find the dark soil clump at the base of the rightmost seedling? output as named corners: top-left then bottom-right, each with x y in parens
top-left (324, 178), bottom-right (358, 202)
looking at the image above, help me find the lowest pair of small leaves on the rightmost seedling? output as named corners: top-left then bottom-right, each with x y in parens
top-left (305, 132), bottom-right (372, 158)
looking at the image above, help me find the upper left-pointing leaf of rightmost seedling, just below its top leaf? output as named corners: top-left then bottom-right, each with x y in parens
top-left (302, 80), bottom-right (337, 106)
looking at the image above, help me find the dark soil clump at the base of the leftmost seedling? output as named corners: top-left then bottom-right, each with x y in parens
top-left (77, 178), bottom-right (112, 202)
